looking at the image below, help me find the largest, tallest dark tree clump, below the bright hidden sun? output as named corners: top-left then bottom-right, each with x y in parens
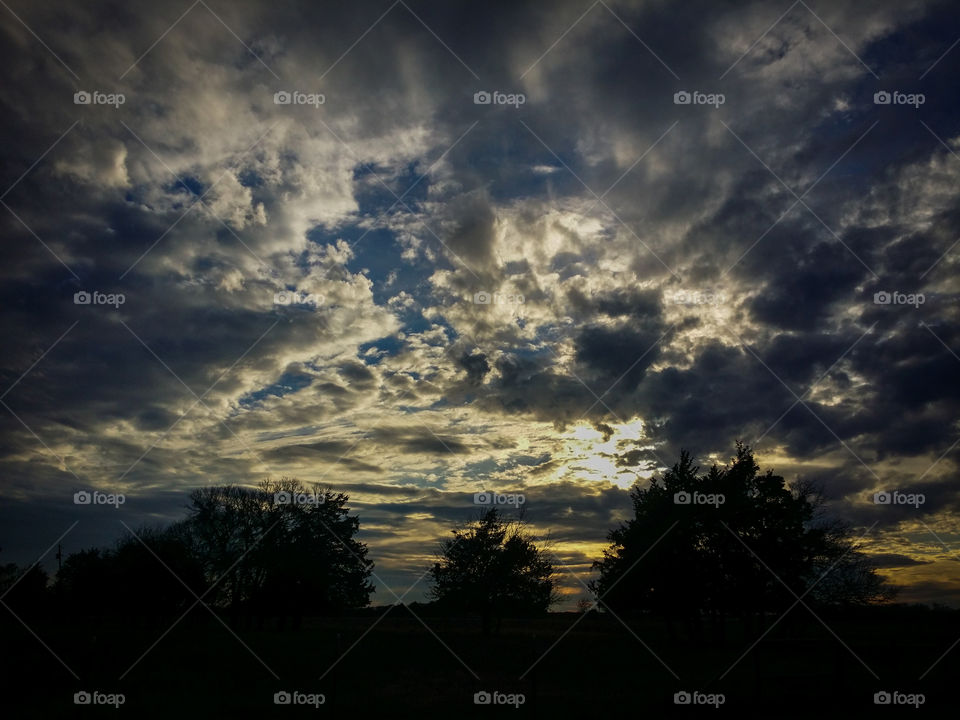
top-left (591, 443), bottom-right (893, 638)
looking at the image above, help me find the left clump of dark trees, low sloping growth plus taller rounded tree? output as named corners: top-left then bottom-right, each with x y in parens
top-left (54, 478), bottom-right (374, 624)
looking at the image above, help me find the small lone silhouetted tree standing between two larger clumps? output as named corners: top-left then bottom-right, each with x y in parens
top-left (429, 508), bottom-right (557, 633)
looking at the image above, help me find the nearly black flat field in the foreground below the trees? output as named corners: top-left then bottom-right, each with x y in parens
top-left (0, 607), bottom-right (960, 718)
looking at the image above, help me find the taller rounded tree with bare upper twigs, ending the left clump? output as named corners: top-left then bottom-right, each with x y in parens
top-left (181, 478), bottom-right (374, 626)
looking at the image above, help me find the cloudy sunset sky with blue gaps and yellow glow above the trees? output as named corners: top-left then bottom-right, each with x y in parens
top-left (0, 0), bottom-right (960, 609)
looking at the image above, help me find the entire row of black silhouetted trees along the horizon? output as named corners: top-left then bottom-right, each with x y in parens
top-left (0, 444), bottom-right (895, 637)
